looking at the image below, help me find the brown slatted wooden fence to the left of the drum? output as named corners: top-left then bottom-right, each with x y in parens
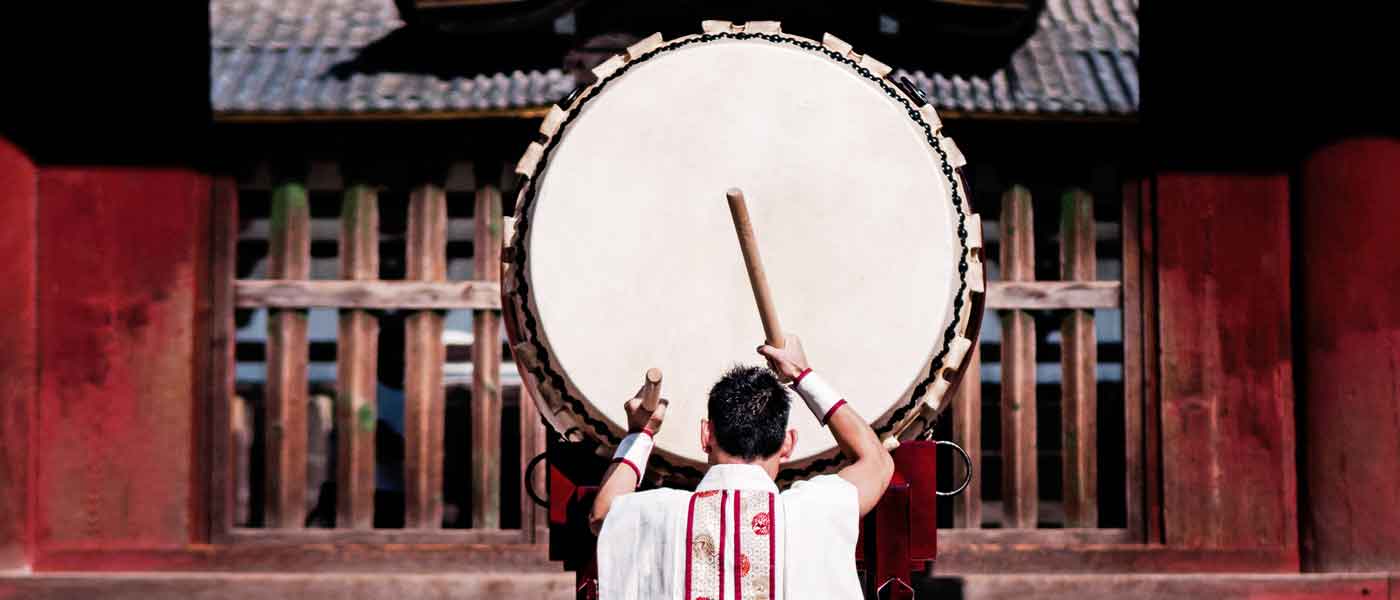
top-left (211, 165), bottom-right (545, 543)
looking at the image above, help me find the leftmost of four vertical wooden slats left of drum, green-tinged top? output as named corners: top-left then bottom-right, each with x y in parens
top-left (263, 183), bottom-right (311, 529)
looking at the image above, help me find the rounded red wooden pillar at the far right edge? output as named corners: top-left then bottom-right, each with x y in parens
top-left (1299, 138), bottom-right (1400, 571)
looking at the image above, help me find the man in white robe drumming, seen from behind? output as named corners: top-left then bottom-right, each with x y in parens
top-left (589, 336), bottom-right (895, 600)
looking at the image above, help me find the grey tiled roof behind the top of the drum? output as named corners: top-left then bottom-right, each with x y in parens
top-left (210, 0), bottom-right (1138, 117)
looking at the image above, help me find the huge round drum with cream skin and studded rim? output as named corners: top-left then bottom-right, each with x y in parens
top-left (503, 22), bottom-right (984, 483)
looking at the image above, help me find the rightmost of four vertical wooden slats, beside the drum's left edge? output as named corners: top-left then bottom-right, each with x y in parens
top-left (472, 186), bottom-right (504, 529)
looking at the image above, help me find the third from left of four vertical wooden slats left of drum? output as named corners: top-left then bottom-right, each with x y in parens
top-left (403, 183), bottom-right (447, 529)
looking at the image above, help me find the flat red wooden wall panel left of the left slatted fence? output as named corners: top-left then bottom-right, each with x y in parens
top-left (35, 168), bottom-right (210, 552)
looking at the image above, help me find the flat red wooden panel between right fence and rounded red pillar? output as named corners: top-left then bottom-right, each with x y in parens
top-left (1156, 175), bottom-right (1298, 550)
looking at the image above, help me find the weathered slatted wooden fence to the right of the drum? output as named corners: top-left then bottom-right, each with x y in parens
top-left (945, 186), bottom-right (1145, 544)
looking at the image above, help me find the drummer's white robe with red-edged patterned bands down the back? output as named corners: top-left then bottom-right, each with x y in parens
top-left (598, 464), bottom-right (861, 600)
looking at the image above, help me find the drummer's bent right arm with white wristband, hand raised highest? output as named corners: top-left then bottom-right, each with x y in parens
top-left (759, 336), bottom-right (895, 516)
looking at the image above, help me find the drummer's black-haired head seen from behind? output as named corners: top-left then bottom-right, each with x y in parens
top-left (700, 365), bottom-right (797, 477)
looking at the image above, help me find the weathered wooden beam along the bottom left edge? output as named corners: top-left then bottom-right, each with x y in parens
top-left (0, 573), bottom-right (574, 600)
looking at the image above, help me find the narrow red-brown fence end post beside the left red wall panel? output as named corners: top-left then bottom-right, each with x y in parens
top-left (207, 176), bottom-right (238, 541)
